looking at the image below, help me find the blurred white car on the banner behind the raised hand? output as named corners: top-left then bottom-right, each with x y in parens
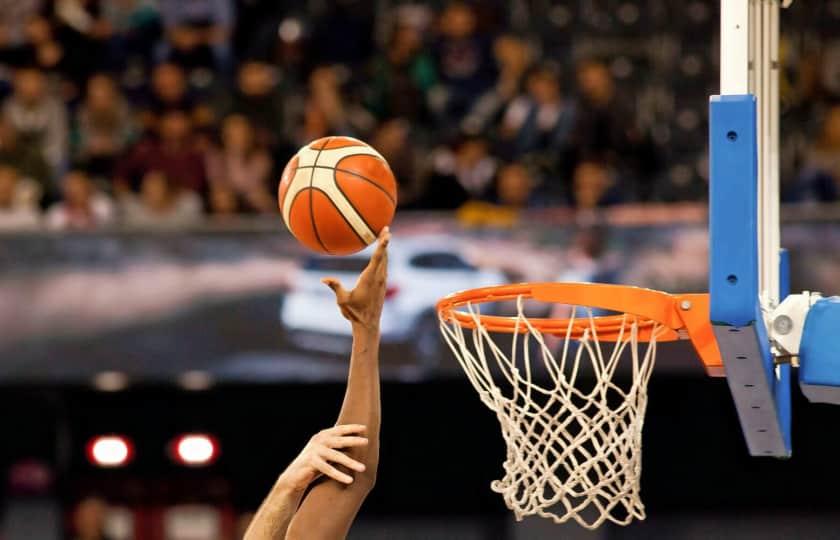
top-left (280, 236), bottom-right (506, 366)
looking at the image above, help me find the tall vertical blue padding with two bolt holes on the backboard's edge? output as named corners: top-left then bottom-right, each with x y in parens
top-left (709, 95), bottom-right (759, 326)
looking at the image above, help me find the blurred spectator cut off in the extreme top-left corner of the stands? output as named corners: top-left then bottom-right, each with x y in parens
top-left (0, 0), bottom-right (46, 66)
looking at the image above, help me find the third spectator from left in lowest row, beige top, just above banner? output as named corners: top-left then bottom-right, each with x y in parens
top-left (121, 171), bottom-right (201, 229)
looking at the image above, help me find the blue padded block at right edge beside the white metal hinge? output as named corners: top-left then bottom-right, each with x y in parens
top-left (799, 296), bottom-right (840, 390)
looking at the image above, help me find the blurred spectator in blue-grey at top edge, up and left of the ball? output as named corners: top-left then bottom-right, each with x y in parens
top-left (160, 0), bottom-right (235, 72)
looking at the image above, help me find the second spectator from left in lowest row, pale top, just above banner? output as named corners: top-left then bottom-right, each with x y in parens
top-left (46, 169), bottom-right (114, 230)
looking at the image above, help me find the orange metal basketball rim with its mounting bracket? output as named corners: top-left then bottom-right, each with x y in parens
top-left (437, 283), bottom-right (723, 375)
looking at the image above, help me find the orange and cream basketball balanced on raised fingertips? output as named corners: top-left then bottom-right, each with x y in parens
top-left (278, 137), bottom-right (397, 255)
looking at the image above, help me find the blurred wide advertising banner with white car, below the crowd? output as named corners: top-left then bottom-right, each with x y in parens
top-left (0, 205), bottom-right (840, 384)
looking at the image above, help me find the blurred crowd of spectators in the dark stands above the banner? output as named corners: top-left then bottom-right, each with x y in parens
top-left (0, 0), bottom-right (840, 230)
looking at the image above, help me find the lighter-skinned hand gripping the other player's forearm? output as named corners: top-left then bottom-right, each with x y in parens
top-left (278, 424), bottom-right (368, 491)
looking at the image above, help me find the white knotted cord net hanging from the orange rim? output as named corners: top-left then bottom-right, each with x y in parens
top-left (441, 297), bottom-right (664, 529)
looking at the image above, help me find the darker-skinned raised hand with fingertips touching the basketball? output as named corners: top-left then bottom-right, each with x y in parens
top-left (322, 227), bottom-right (391, 329)
